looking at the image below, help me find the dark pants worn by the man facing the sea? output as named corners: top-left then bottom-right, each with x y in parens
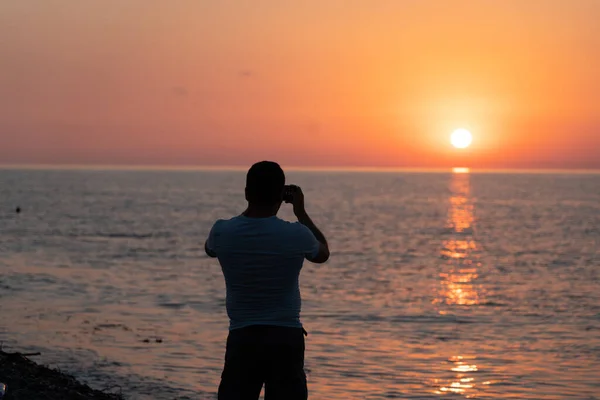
top-left (219, 325), bottom-right (308, 400)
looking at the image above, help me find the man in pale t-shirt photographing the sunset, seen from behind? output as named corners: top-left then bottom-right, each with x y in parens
top-left (205, 161), bottom-right (329, 400)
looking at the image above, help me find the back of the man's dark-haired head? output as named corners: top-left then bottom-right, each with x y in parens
top-left (246, 161), bottom-right (285, 206)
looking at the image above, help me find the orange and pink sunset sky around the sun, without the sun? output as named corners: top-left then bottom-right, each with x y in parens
top-left (0, 0), bottom-right (600, 169)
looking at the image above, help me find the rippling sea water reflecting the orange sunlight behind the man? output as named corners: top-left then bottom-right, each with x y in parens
top-left (0, 170), bottom-right (600, 400)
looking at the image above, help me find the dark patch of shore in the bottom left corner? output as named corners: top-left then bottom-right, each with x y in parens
top-left (0, 350), bottom-right (123, 400)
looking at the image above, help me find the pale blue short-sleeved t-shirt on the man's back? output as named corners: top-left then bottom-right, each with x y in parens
top-left (208, 216), bottom-right (320, 330)
